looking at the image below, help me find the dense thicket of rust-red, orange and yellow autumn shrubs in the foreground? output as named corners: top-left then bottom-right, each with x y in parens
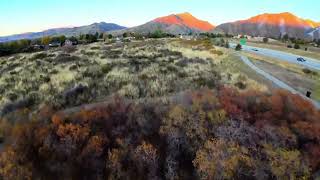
top-left (0, 88), bottom-right (320, 179)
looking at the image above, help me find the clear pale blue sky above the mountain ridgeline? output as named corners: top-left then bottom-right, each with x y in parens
top-left (0, 0), bottom-right (320, 36)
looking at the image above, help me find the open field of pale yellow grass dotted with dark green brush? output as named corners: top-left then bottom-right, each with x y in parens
top-left (0, 39), bottom-right (267, 117)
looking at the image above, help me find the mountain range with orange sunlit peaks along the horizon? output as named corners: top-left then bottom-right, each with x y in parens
top-left (0, 12), bottom-right (320, 42)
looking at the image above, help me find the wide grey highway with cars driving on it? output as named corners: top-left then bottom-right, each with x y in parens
top-left (230, 43), bottom-right (320, 70)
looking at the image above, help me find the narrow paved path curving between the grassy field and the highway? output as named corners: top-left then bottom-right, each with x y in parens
top-left (240, 55), bottom-right (320, 109)
